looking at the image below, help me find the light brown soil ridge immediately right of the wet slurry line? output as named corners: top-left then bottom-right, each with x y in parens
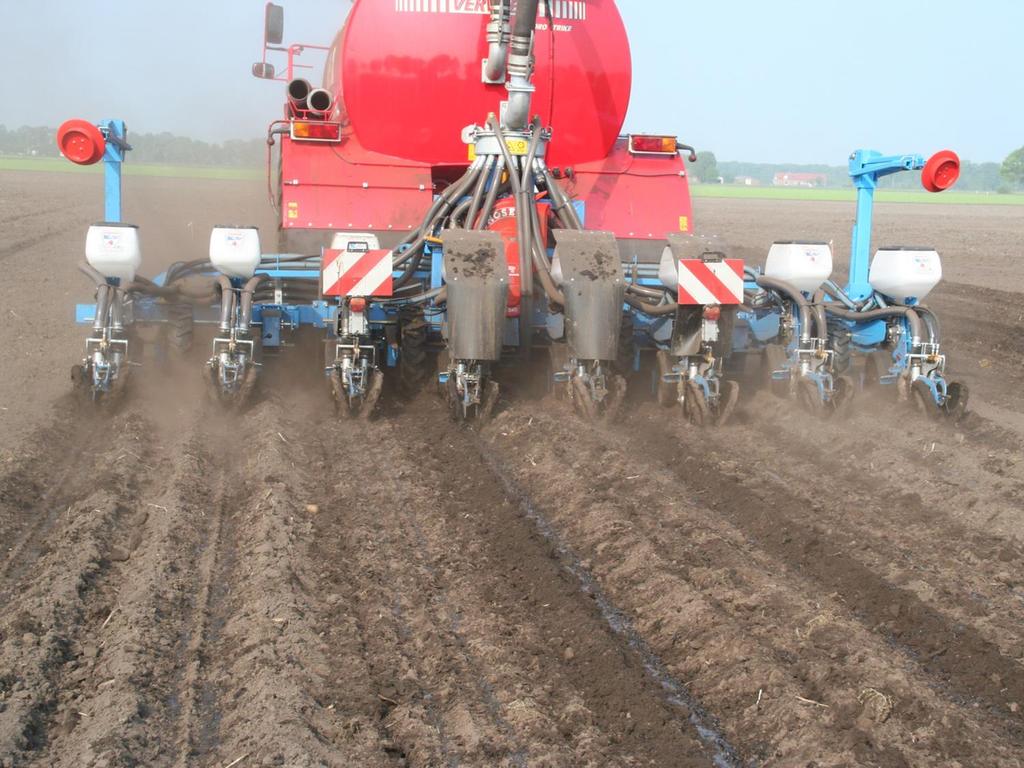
top-left (488, 411), bottom-right (1019, 766)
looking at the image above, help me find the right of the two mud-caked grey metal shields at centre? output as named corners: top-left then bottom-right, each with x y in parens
top-left (554, 229), bottom-right (626, 360)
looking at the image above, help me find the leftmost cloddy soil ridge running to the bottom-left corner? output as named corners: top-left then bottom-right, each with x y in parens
top-left (0, 415), bottom-right (159, 765)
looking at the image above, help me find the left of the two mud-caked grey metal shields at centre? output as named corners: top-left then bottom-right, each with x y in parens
top-left (441, 229), bottom-right (509, 360)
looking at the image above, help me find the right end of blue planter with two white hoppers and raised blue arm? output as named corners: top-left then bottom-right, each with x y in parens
top-left (733, 150), bottom-right (968, 419)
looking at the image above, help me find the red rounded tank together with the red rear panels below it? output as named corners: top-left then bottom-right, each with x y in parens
top-left (279, 0), bottom-right (692, 261)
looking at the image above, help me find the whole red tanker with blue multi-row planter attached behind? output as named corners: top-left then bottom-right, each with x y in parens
top-left (60, 0), bottom-right (965, 424)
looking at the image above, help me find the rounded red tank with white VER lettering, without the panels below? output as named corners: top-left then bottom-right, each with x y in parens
top-left (326, 0), bottom-right (633, 166)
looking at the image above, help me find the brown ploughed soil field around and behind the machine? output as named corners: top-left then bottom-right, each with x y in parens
top-left (0, 173), bottom-right (1024, 768)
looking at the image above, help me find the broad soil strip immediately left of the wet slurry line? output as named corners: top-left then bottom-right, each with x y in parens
top-left (311, 398), bottom-right (729, 765)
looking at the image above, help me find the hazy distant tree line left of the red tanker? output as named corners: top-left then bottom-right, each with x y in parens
top-left (0, 125), bottom-right (266, 168)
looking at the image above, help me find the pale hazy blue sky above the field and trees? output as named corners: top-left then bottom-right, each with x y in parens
top-left (0, 0), bottom-right (1024, 165)
